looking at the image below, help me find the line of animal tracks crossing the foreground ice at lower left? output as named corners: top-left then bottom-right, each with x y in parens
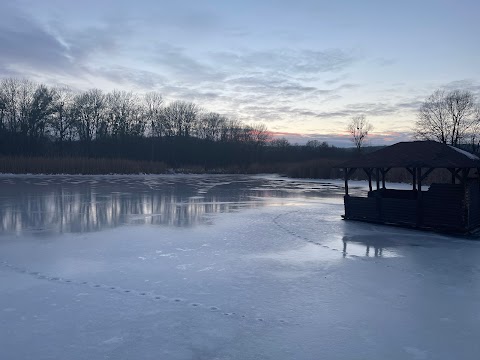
top-left (0, 260), bottom-right (288, 325)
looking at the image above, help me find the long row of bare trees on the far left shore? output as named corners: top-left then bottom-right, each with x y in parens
top-left (0, 78), bottom-right (348, 167)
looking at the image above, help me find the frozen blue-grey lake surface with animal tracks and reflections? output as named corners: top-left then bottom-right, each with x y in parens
top-left (0, 175), bottom-right (480, 360)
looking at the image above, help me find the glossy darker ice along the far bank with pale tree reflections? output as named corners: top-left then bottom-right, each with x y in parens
top-left (0, 175), bottom-right (352, 234)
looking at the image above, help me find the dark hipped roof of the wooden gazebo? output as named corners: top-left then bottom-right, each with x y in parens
top-left (338, 141), bottom-right (480, 168)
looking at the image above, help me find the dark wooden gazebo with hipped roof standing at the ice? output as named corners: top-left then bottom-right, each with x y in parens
top-left (339, 141), bottom-right (480, 232)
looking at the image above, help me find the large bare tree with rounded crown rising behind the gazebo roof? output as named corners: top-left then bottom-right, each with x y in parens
top-left (415, 90), bottom-right (479, 146)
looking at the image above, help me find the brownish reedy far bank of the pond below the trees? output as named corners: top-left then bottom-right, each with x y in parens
top-left (0, 156), bottom-right (458, 184)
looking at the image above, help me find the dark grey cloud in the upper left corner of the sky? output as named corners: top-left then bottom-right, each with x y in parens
top-left (0, 3), bottom-right (126, 78)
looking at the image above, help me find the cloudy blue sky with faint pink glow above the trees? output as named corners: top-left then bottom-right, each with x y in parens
top-left (0, 0), bottom-right (480, 146)
